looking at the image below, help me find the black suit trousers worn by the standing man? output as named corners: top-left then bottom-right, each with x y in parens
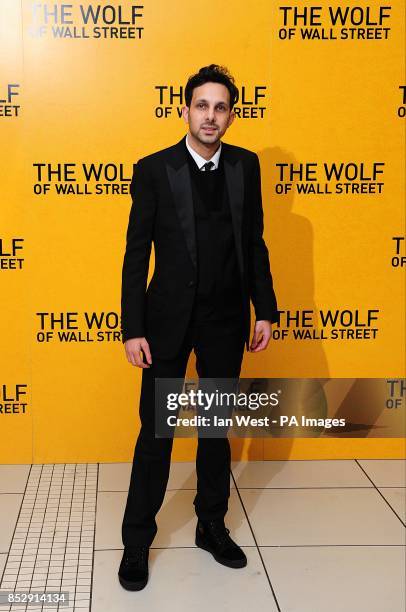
top-left (122, 316), bottom-right (244, 546)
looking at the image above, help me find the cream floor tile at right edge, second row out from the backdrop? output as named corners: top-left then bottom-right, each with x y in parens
top-left (240, 489), bottom-right (405, 546)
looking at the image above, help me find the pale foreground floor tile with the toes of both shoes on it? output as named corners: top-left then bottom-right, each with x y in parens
top-left (92, 548), bottom-right (277, 612)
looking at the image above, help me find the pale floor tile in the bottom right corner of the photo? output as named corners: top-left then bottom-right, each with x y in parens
top-left (260, 546), bottom-right (405, 612)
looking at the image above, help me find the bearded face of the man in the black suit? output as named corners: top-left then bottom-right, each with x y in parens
top-left (182, 83), bottom-right (234, 144)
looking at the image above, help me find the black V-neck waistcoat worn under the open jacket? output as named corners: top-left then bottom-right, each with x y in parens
top-left (187, 146), bottom-right (243, 322)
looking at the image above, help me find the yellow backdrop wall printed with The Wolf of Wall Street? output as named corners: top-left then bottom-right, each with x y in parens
top-left (0, 0), bottom-right (405, 463)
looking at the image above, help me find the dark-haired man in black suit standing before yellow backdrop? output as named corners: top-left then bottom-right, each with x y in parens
top-left (119, 64), bottom-right (278, 590)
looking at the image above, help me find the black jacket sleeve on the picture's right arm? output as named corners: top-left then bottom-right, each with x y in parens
top-left (249, 154), bottom-right (279, 323)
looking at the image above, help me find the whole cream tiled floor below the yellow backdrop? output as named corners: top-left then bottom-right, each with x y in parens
top-left (0, 459), bottom-right (406, 612)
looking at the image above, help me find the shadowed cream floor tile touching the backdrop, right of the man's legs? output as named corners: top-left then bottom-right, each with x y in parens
top-left (231, 460), bottom-right (373, 489)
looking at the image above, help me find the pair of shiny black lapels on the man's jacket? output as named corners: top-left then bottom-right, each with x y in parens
top-left (166, 136), bottom-right (244, 276)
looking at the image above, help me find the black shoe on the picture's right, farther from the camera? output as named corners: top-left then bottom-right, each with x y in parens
top-left (196, 519), bottom-right (247, 568)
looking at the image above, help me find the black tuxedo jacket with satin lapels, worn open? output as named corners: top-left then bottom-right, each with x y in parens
top-left (121, 136), bottom-right (279, 359)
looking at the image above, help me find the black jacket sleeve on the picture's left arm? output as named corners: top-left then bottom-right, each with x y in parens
top-left (121, 159), bottom-right (156, 342)
